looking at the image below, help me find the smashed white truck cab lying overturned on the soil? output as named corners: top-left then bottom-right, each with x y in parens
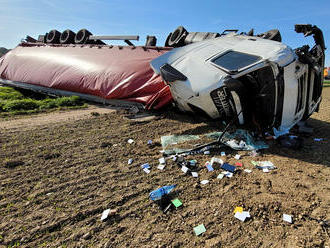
top-left (151, 25), bottom-right (325, 134)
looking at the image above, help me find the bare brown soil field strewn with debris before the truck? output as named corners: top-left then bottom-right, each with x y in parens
top-left (0, 88), bottom-right (330, 247)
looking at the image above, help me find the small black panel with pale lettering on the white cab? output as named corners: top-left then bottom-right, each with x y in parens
top-left (210, 87), bottom-right (233, 118)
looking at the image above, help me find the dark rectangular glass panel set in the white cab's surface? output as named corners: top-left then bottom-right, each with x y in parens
top-left (212, 51), bottom-right (261, 72)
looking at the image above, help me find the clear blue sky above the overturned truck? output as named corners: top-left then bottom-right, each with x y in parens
top-left (0, 0), bottom-right (330, 66)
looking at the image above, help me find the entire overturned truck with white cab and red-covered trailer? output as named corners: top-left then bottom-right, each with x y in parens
top-left (0, 24), bottom-right (325, 134)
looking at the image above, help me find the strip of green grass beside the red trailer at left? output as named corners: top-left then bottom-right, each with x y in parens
top-left (0, 87), bottom-right (87, 116)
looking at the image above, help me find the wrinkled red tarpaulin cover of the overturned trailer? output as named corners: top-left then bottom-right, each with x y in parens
top-left (0, 43), bottom-right (172, 109)
